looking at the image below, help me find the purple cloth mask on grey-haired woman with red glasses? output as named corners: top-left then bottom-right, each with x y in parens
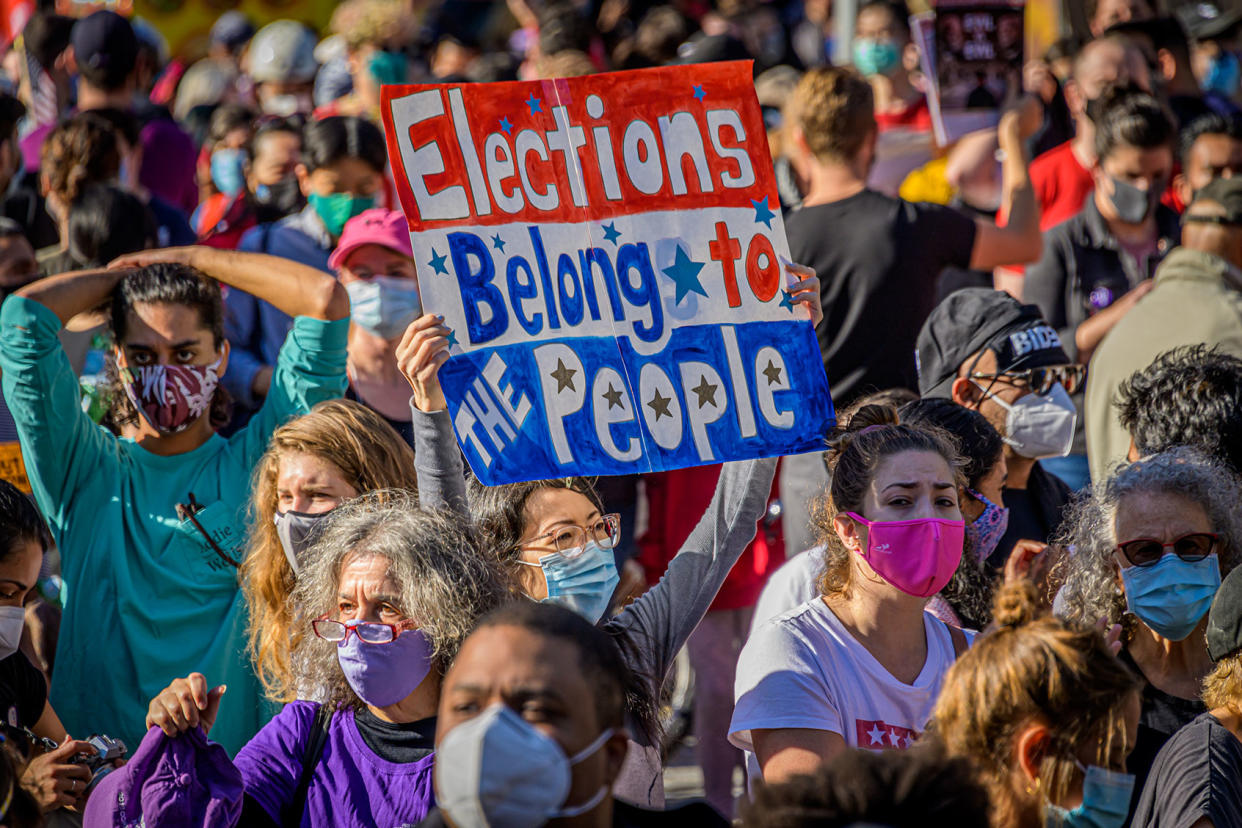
top-left (337, 624), bottom-right (435, 708)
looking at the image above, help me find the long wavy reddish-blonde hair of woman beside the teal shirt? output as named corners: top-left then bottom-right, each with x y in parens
top-left (240, 400), bottom-right (416, 701)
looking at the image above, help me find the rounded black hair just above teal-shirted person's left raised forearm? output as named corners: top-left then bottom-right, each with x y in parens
top-left (66, 184), bottom-right (159, 269)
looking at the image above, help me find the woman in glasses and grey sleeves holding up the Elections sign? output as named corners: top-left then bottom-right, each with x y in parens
top-left (397, 264), bottom-right (822, 808)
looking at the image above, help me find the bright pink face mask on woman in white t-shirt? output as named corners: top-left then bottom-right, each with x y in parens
top-left (846, 511), bottom-right (966, 598)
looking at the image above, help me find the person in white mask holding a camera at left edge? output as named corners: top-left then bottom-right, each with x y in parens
top-left (0, 480), bottom-right (94, 813)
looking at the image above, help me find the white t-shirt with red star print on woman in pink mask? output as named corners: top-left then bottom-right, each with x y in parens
top-left (729, 598), bottom-right (972, 778)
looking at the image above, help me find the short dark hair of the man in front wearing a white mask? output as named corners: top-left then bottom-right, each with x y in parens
top-left (476, 601), bottom-right (633, 727)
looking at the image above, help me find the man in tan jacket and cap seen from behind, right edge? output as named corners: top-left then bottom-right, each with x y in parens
top-left (1086, 178), bottom-right (1242, 479)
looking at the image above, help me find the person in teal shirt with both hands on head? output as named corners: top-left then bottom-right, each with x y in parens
top-left (0, 247), bottom-right (349, 754)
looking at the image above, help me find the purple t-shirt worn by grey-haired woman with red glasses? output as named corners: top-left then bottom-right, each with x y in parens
top-left (233, 701), bottom-right (435, 828)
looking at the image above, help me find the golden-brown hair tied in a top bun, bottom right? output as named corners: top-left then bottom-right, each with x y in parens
top-left (929, 581), bottom-right (1141, 826)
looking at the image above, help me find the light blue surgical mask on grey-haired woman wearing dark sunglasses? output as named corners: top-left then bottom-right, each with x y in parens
top-left (1122, 554), bottom-right (1221, 641)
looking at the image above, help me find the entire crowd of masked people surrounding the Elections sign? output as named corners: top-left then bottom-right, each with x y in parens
top-left (0, 0), bottom-right (1242, 828)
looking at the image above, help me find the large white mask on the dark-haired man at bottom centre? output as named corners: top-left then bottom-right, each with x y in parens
top-left (435, 704), bottom-right (612, 828)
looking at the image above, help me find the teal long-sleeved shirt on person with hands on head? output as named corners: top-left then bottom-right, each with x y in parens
top-left (0, 297), bottom-right (349, 754)
